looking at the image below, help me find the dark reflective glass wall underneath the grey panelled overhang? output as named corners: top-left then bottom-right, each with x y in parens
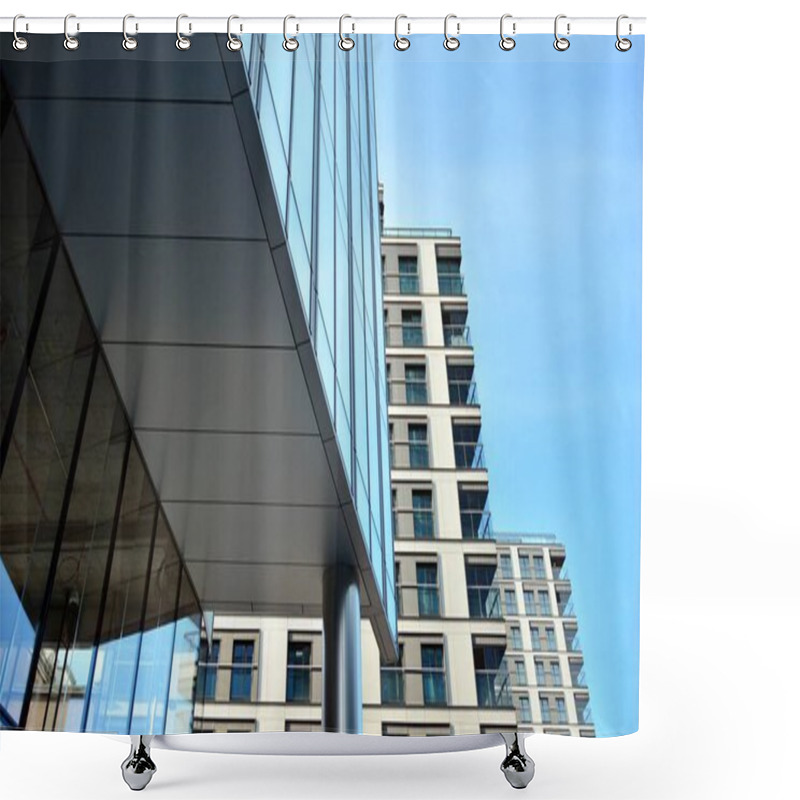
top-left (0, 101), bottom-right (202, 734)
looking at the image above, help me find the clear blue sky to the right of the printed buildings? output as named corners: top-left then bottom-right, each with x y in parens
top-left (374, 36), bottom-right (644, 736)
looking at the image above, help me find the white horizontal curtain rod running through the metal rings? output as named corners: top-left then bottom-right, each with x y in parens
top-left (0, 15), bottom-right (645, 36)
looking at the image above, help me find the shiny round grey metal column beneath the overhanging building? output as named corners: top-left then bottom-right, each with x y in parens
top-left (322, 565), bottom-right (362, 733)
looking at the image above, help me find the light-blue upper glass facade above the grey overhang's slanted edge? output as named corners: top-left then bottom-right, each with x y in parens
top-left (242, 34), bottom-right (397, 634)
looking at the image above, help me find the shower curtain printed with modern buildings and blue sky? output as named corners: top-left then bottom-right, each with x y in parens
top-left (0, 26), bottom-right (644, 752)
